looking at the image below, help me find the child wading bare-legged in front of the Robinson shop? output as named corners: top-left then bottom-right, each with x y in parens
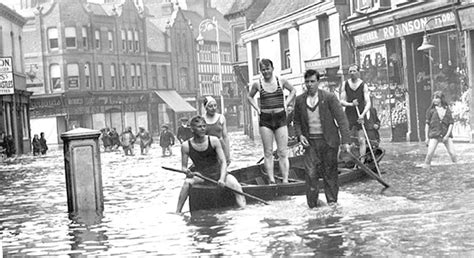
top-left (421, 91), bottom-right (456, 168)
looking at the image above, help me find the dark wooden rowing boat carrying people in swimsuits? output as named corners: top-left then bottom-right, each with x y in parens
top-left (189, 148), bottom-right (385, 211)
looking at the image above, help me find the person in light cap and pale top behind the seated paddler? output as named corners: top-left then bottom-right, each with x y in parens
top-left (203, 96), bottom-right (230, 165)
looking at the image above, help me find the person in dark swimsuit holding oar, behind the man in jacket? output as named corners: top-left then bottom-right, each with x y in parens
top-left (341, 65), bottom-right (371, 162)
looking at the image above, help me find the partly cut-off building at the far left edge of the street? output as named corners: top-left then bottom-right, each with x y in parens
top-left (0, 3), bottom-right (32, 154)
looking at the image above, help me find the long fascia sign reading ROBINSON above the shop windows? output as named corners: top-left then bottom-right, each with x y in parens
top-left (354, 12), bottom-right (455, 46)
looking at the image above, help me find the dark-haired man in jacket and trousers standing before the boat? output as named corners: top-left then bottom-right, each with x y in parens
top-left (294, 70), bottom-right (350, 208)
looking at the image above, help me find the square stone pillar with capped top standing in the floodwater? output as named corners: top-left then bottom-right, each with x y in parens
top-left (61, 128), bottom-right (104, 213)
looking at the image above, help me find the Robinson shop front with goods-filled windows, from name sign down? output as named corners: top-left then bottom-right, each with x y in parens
top-left (351, 7), bottom-right (470, 141)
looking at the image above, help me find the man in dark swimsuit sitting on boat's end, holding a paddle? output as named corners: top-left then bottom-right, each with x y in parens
top-left (176, 116), bottom-right (246, 213)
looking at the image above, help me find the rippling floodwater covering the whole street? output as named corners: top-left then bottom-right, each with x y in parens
top-left (0, 133), bottom-right (474, 257)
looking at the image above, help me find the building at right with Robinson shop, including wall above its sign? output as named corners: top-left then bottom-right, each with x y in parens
top-left (342, 0), bottom-right (472, 141)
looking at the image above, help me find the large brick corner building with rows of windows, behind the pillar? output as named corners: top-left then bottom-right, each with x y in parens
top-left (22, 0), bottom-right (178, 143)
